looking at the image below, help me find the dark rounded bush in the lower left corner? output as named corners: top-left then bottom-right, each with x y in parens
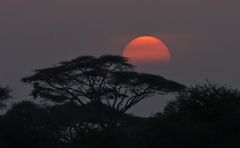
top-left (0, 101), bottom-right (59, 148)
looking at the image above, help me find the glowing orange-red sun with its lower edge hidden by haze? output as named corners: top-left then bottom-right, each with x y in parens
top-left (123, 36), bottom-right (170, 62)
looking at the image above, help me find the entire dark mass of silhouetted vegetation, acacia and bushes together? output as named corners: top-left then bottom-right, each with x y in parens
top-left (0, 56), bottom-right (240, 148)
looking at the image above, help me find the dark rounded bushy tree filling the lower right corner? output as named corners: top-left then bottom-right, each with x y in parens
top-left (142, 83), bottom-right (240, 148)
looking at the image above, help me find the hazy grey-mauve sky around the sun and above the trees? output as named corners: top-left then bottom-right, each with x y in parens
top-left (0, 0), bottom-right (240, 115)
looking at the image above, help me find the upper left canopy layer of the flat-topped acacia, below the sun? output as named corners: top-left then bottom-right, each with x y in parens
top-left (23, 55), bottom-right (133, 82)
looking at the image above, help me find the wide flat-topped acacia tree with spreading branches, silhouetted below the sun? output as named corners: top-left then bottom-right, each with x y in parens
top-left (23, 55), bottom-right (184, 125)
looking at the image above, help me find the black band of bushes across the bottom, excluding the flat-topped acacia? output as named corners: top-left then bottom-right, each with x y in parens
top-left (0, 82), bottom-right (240, 148)
